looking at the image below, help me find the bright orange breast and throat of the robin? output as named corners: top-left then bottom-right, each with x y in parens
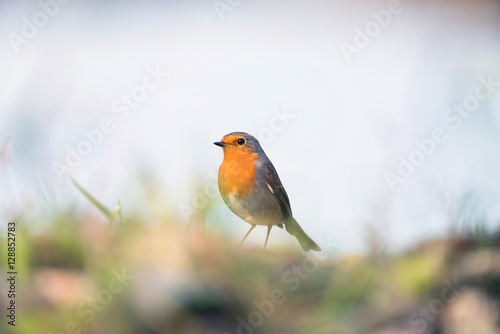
top-left (219, 147), bottom-right (258, 197)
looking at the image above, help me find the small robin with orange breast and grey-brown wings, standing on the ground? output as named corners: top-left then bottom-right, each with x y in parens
top-left (214, 132), bottom-right (321, 252)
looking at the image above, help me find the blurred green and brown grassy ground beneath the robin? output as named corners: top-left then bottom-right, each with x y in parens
top-left (0, 184), bottom-right (500, 334)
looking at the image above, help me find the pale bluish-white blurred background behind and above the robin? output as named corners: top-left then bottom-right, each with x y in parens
top-left (0, 1), bottom-right (500, 252)
